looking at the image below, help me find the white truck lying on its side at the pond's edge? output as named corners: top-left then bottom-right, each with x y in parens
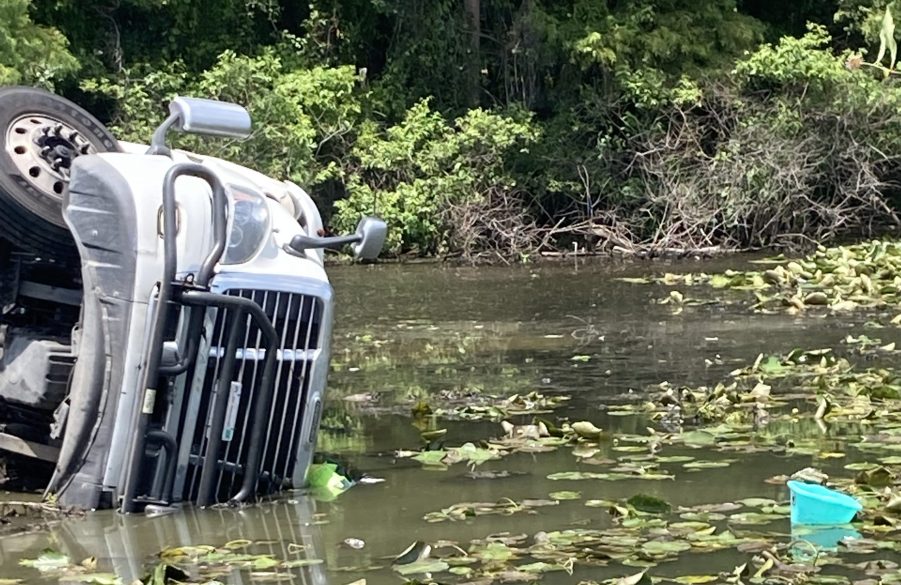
top-left (0, 87), bottom-right (386, 512)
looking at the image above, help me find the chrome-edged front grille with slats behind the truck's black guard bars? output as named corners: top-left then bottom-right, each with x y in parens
top-left (184, 289), bottom-right (322, 501)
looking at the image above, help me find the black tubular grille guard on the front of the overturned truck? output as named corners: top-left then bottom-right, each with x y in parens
top-left (120, 163), bottom-right (279, 513)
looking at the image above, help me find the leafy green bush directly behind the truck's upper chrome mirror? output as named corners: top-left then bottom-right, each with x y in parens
top-left (82, 50), bottom-right (362, 188)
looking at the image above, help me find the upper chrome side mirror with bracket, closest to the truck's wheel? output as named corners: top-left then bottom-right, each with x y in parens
top-left (147, 96), bottom-right (253, 155)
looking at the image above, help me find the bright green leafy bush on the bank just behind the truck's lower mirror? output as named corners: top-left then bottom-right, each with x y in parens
top-left (335, 99), bottom-right (537, 253)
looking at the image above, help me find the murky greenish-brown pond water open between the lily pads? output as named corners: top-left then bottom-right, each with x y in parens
top-left (0, 258), bottom-right (901, 585)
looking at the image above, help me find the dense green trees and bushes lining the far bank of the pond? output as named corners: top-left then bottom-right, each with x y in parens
top-left (8, 0), bottom-right (901, 259)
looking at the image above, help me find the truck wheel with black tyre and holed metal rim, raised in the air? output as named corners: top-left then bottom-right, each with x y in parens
top-left (0, 87), bottom-right (120, 258)
